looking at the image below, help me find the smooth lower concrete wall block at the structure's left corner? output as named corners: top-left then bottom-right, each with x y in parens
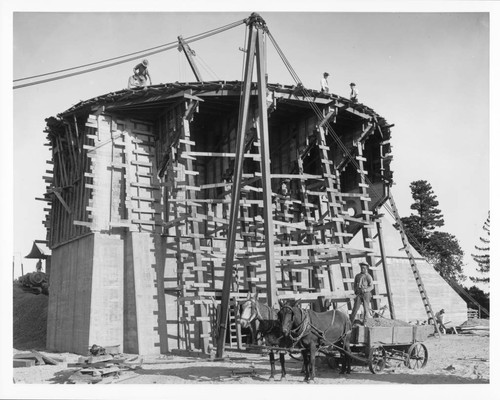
top-left (47, 232), bottom-right (166, 355)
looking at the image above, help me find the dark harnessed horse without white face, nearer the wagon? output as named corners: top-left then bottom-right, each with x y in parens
top-left (279, 301), bottom-right (352, 382)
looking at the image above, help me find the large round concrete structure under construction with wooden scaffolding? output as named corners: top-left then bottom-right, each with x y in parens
top-left (17, 14), bottom-right (474, 356)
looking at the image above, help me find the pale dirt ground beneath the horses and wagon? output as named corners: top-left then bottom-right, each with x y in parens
top-left (14, 334), bottom-right (490, 386)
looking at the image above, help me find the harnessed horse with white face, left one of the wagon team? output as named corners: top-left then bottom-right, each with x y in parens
top-left (239, 293), bottom-right (291, 379)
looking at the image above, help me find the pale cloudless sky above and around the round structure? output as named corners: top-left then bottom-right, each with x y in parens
top-left (0, 0), bottom-right (500, 398)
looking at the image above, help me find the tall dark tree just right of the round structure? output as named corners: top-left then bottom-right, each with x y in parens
top-left (401, 180), bottom-right (465, 282)
